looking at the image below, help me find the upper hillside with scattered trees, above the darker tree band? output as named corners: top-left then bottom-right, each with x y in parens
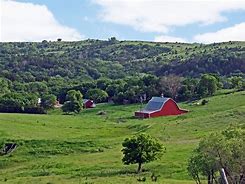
top-left (0, 39), bottom-right (245, 82)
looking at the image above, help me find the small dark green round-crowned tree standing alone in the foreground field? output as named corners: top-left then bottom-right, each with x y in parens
top-left (122, 134), bottom-right (164, 173)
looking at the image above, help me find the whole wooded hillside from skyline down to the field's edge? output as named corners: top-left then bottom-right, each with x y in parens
top-left (0, 37), bottom-right (245, 112)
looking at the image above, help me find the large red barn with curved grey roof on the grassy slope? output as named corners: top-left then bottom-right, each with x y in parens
top-left (135, 97), bottom-right (188, 118)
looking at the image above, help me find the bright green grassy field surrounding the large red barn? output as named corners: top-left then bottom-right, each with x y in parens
top-left (0, 91), bottom-right (245, 184)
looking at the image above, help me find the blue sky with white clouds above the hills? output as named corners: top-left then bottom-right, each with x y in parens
top-left (0, 0), bottom-right (245, 43)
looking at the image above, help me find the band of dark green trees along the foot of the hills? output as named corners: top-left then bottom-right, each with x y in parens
top-left (0, 74), bottom-right (245, 113)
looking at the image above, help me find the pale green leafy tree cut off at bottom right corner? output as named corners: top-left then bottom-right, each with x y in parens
top-left (188, 127), bottom-right (245, 184)
